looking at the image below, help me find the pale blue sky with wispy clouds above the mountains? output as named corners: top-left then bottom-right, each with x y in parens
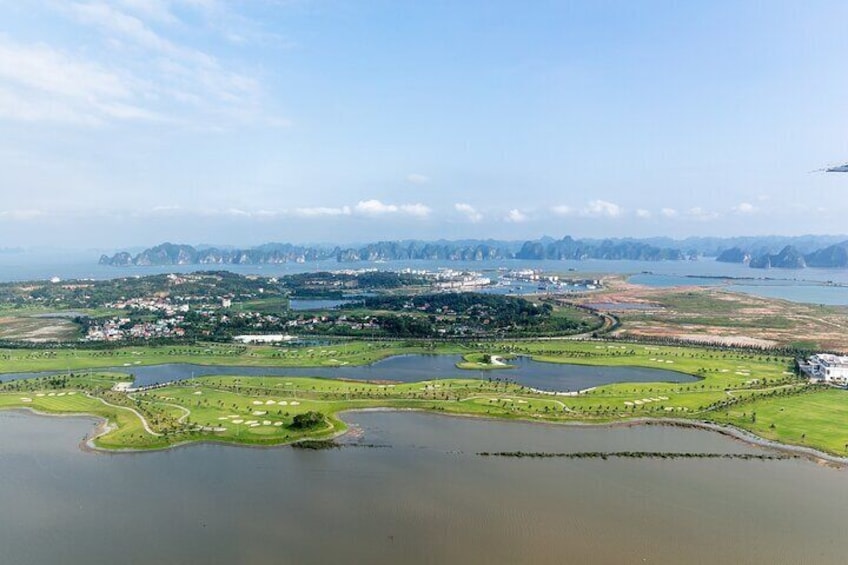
top-left (0, 0), bottom-right (848, 248)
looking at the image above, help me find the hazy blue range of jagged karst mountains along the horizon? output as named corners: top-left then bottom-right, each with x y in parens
top-left (100, 236), bottom-right (848, 268)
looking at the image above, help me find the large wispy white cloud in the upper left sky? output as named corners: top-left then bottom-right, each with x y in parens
top-left (0, 0), bottom-right (290, 130)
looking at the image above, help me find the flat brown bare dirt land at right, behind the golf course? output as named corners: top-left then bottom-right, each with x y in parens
top-left (576, 277), bottom-right (848, 351)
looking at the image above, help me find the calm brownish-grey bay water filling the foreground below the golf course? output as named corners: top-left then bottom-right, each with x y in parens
top-left (0, 412), bottom-right (848, 565)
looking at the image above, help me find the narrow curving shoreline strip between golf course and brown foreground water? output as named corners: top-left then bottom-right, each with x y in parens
top-left (3, 407), bottom-right (848, 470)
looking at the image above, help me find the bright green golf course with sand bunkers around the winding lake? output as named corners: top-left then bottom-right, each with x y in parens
top-left (0, 340), bottom-right (848, 454)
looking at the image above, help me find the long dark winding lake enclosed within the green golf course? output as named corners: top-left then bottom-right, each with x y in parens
top-left (0, 355), bottom-right (699, 392)
